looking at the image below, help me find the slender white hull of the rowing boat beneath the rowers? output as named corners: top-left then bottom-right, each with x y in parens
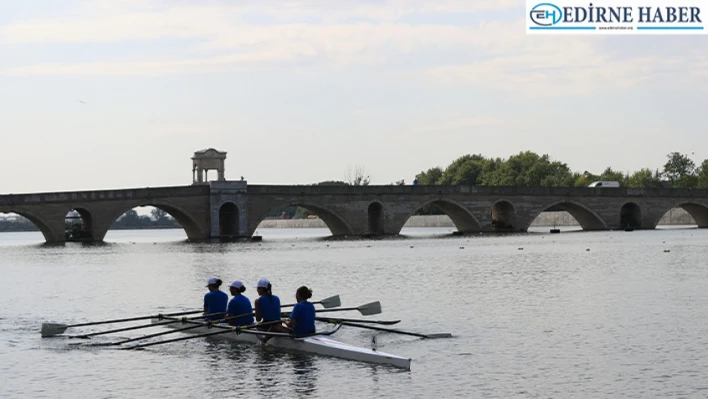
top-left (151, 318), bottom-right (411, 370)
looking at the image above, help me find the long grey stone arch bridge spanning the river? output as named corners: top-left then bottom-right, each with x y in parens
top-left (0, 181), bottom-right (708, 242)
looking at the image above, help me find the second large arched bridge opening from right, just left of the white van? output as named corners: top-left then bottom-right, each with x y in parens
top-left (530, 201), bottom-right (607, 232)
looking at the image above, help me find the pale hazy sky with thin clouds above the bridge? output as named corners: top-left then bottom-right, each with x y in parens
top-left (0, 0), bottom-right (708, 193)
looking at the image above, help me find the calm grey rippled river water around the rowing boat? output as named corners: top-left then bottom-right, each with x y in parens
top-left (0, 229), bottom-right (708, 398)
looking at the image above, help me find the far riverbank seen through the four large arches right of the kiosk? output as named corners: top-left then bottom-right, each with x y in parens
top-left (258, 208), bottom-right (696, 229)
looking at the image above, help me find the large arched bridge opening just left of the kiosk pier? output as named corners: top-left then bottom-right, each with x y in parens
top-left (103, 205), bottom-right (190, 242)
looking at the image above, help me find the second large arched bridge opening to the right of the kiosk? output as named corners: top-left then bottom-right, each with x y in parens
top-left (401, 199), bottom-right (482, 235)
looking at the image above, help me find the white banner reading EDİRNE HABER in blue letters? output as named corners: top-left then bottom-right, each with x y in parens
top-left (526, 0), bottom-right (708, 35)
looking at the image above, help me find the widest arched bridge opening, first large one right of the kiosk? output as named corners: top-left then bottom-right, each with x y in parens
top-left (254, 202), bottom-right (353, 237)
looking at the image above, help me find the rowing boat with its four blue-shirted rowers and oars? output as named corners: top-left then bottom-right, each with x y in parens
top-left (42, 277), bottom-right (452, 370)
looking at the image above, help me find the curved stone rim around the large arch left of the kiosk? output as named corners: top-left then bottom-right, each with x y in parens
top-left (92, 199), bottom-right (205, 240)
